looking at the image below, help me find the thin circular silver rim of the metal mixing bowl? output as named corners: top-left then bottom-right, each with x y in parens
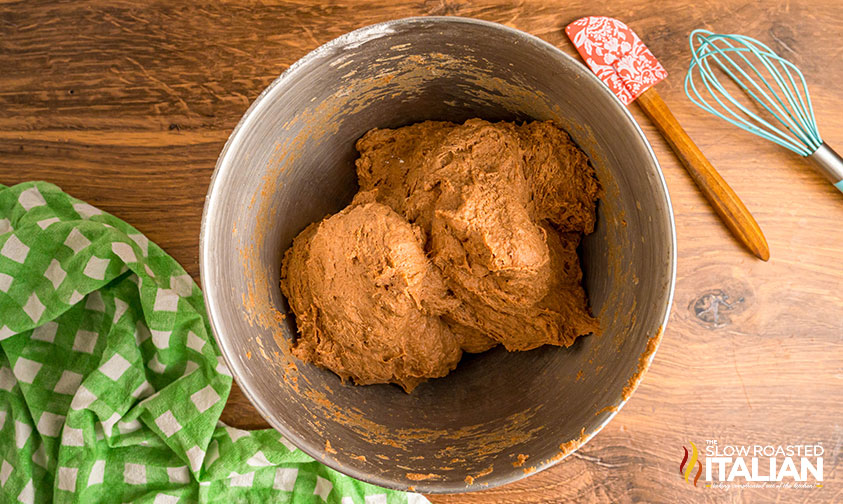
top-left (199, 16), bottom-right (677, 494)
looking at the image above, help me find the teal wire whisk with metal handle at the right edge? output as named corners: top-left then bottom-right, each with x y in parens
top-left (685, 30), bottom-right (843, 191)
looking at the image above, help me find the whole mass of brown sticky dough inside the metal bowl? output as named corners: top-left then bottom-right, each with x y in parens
top-left (281, 119), bottom-right (599, 392)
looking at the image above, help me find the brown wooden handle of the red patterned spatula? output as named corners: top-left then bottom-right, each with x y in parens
top-left (637, 88), bottom-right (770, 261)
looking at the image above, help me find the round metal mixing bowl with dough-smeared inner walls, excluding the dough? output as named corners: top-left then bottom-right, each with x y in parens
top-left (200, 17), bottom-right (676, 492)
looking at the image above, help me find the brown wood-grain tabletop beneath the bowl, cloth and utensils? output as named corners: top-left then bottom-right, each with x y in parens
top-left (0, 0), bottom-right (843, 503)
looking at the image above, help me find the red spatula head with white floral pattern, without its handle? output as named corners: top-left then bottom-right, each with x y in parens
top-left (565, 16), bottom-right (667, 105)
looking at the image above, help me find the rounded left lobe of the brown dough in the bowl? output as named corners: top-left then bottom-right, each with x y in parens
top-left (281, 203), bottom-right (462, 392)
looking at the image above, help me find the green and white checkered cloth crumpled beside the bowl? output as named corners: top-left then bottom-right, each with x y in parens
top-left (0, 182), bottom-right (427, 504)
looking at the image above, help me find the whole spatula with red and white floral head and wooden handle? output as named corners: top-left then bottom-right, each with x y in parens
top-left (565, 16), bottom-right (770, 261)
